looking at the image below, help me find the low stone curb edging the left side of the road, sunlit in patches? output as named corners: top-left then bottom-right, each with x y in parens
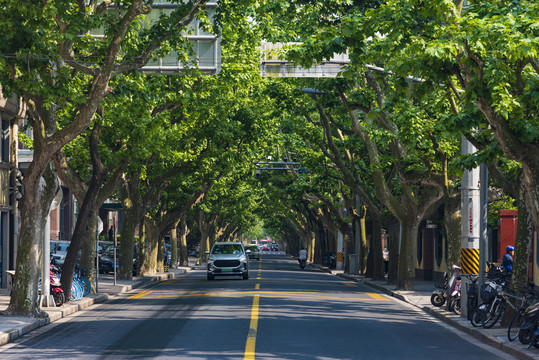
top-left (0, 269), bottom-right (181, 346)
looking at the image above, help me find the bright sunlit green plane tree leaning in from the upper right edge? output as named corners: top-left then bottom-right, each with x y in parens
top-left (358, 1), bottom-right (539, 231)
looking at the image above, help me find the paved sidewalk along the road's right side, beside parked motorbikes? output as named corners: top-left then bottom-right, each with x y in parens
top-left (334, 270), bottom-right (539, 360)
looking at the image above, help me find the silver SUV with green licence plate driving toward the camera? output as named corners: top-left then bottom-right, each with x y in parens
top-left (208, 242), bottom-right (250, 280)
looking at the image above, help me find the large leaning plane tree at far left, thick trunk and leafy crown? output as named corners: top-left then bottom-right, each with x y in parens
top-left (0, 0), bottom-right (217, 316)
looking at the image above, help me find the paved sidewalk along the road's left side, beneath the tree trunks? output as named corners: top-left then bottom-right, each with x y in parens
top-left (0, 267), bottom-right (191, 346)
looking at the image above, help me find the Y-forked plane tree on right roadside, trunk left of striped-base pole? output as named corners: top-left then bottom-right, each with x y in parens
top-left (255, 2), bottom-right (466, 288)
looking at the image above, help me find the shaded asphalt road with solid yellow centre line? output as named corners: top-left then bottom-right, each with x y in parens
top-left (0, 255), bottom-right (510, 360)
